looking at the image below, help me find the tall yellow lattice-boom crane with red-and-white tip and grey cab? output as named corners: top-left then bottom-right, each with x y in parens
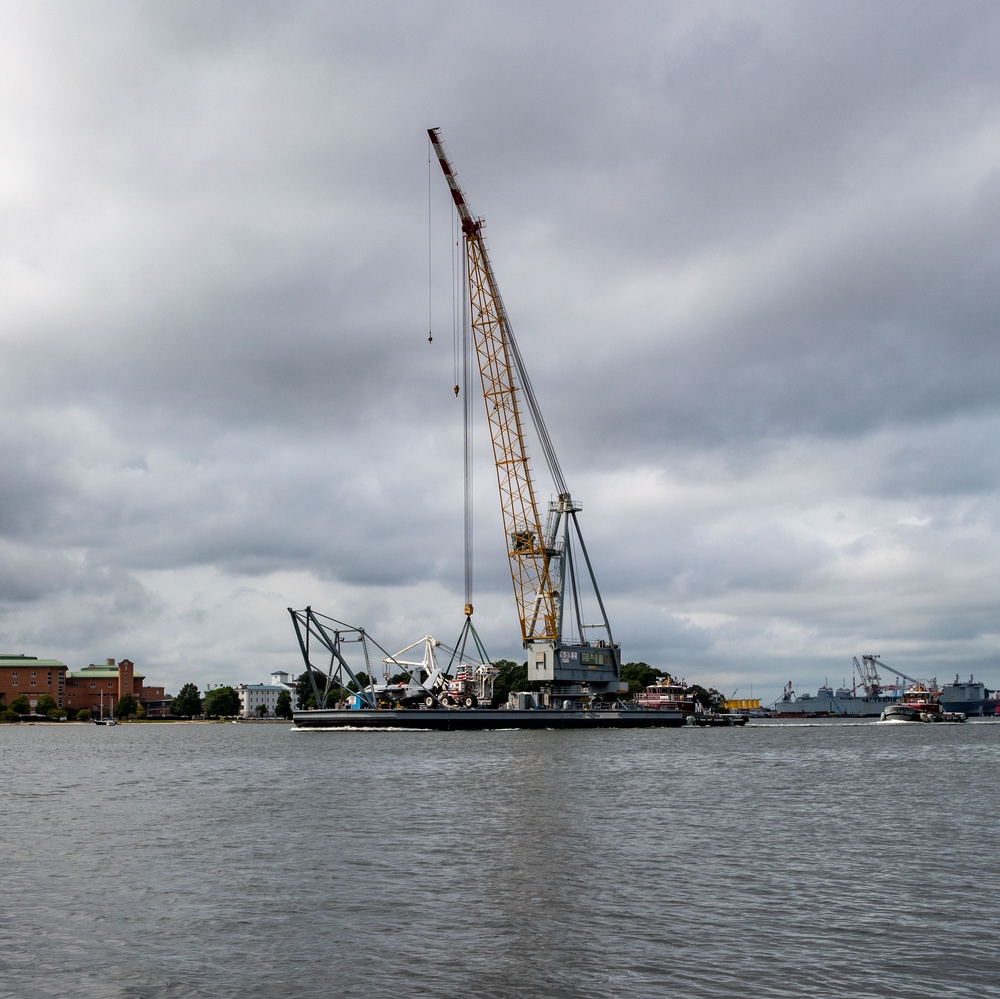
top-left (428, 128), bottom-right (627, 703)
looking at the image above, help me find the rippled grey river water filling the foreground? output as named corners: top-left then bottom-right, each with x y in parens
top-left (0, 722), bottom-right (1000, 999)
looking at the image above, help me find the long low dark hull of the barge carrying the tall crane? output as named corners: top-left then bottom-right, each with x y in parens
top-left (292, 708), bottom-right (685, 732)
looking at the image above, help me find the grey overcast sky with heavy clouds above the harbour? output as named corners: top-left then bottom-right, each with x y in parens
top-left (0, 0), bottom-right (1000, 700)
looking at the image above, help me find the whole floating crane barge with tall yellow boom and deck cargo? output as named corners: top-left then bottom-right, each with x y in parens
top-left (289, 128), bottom-right (688, 729)
